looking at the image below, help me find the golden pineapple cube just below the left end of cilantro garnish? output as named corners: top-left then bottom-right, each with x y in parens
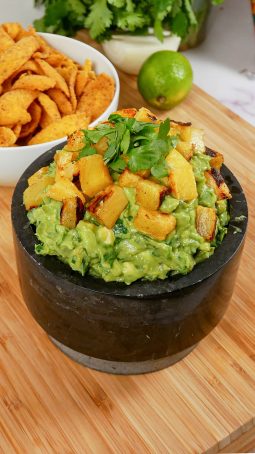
top-left (78, 154), bottom-right (112, 197)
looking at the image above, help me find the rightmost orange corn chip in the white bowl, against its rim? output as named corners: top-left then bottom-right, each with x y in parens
top-left (77, 73), bottom-right (115, 121)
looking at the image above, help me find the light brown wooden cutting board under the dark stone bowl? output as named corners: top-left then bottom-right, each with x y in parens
top-left (0, 55), bottom-right (255, 454)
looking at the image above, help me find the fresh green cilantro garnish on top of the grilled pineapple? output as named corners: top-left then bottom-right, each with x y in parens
top-left (79, 114), bottom-right (178, 178)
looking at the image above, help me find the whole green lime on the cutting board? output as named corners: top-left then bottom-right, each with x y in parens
top-left (137, 50), bottom-right (193, 110)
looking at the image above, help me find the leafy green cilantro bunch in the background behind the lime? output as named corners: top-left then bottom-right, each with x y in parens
top-left (34, 0), bottom-right (224, 42)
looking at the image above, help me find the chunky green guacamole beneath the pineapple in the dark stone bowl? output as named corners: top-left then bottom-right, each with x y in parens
top-left (28, 153), bottom-right (229, 284)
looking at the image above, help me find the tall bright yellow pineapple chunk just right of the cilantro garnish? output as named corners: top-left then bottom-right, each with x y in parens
top-left (166, 149), bottom-right (197, 201)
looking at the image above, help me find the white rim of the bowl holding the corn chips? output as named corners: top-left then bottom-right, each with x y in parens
top-left (0, 32), bottom-right (120, 153)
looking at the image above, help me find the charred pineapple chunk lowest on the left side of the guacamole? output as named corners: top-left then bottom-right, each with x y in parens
top-left (60, 197), bottom-right (84, 229)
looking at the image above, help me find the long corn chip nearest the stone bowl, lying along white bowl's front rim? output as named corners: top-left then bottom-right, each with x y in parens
top-left (28, 114), bottom-right (90, 145)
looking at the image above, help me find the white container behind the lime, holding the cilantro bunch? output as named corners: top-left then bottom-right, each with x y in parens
top-left (102, 32), bottom-right (181, 75)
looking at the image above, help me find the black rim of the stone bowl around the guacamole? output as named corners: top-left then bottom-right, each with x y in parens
top-left (11, 142), bottom-right (248, 299)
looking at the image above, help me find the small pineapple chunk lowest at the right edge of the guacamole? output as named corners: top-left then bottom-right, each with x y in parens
top-left (196, 205), bottom-right (217, 241)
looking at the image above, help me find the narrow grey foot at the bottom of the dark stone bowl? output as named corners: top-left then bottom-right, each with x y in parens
top-left (49, 336), bottom-right (197, 375)
